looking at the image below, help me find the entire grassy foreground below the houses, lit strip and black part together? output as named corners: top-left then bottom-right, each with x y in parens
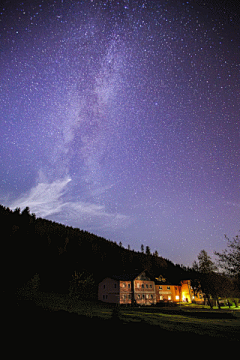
top-left (6, 293), bottom-right (240, 352)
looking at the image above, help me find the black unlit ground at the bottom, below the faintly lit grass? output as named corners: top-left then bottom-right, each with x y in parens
top-left (2, 300), bottom-right (240, 357)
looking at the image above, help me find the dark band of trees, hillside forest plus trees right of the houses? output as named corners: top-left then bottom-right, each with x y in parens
top-left (0, 205), bottom-right (240, 301)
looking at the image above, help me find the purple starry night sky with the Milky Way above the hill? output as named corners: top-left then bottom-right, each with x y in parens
top-left (0, 0), bottom-right (240, 266)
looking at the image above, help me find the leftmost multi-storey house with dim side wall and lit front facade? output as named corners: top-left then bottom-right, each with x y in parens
top-left (98, 271), bottom-right (156, 305)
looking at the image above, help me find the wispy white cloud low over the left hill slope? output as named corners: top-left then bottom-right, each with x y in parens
top-left (9, 177), bottom-right (129, 228)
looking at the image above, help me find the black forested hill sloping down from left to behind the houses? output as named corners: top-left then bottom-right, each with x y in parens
top-left (0, 205), bottom-right (189, 292)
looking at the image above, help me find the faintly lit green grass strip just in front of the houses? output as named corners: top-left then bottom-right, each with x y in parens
top-left (19, 292), bottom-right (240, 342)
